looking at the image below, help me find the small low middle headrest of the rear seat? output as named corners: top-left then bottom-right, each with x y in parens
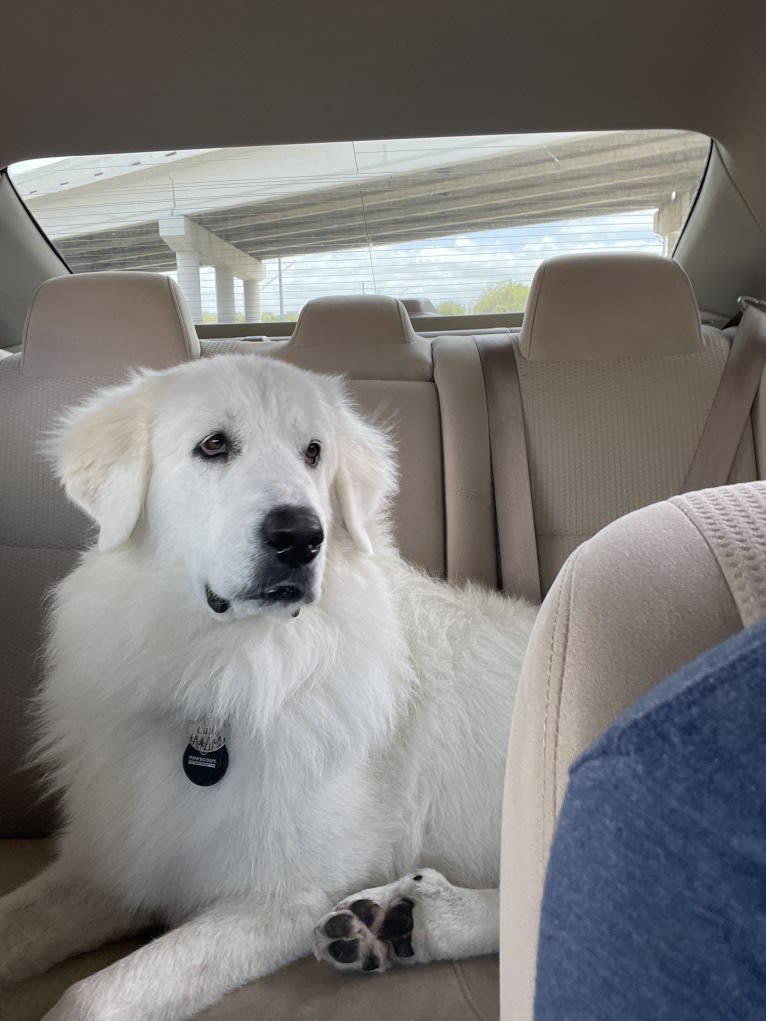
top-left (274, 295), bottom-right (433, 380)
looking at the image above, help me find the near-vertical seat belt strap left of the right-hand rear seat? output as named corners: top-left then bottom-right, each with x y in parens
top-left (474, 337), bottom-right (540, 603)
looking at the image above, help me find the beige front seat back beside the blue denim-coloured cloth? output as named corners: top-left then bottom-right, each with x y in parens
top-left (500, 483), bottom-right (766, 1021)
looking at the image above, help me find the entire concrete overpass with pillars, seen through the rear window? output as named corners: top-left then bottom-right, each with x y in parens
top-left (14, 132), bottom-right (708, 322)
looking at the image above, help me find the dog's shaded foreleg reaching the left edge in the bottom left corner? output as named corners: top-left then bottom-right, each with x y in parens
top-left (0, 861), bottom-right (145, 988)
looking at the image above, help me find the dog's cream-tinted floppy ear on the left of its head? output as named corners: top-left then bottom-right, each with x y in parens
top-left (49, 378), bottom-right (151, 551)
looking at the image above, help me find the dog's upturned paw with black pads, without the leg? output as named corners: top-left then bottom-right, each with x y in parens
top-left (314, 869), bottom-right (452, 972)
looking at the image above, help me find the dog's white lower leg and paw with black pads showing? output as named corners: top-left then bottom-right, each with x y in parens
top-left (314, 869), bottom-right (499, 972)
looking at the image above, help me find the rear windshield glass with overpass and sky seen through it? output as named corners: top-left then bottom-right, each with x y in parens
top-left (9, 131), bottom-right (708, 323)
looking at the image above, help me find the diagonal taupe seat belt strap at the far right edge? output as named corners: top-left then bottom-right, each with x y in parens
top-left (681, 298), bottom-right (766, 493)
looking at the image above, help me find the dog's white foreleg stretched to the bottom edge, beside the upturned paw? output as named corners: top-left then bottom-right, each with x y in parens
top-left (43, 896), bottom-right (327, 1021)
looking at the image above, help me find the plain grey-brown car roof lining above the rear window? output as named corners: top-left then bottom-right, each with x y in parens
top-left (0, 0), bottom-right (766, 163)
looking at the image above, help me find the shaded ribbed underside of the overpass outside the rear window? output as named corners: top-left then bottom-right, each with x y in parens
top-left (49, 132), bottom-right (707, 321)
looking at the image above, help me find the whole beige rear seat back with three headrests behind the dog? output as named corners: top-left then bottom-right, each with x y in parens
top-left (0, 255), bottom-right (766, 832)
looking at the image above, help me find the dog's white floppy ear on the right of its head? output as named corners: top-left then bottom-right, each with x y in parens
top-left (328, 379), bottom-right (397, 554)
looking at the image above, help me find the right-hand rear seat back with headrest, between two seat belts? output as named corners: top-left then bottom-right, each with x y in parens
top-left (495, 254), bottom-right (758, 593)
